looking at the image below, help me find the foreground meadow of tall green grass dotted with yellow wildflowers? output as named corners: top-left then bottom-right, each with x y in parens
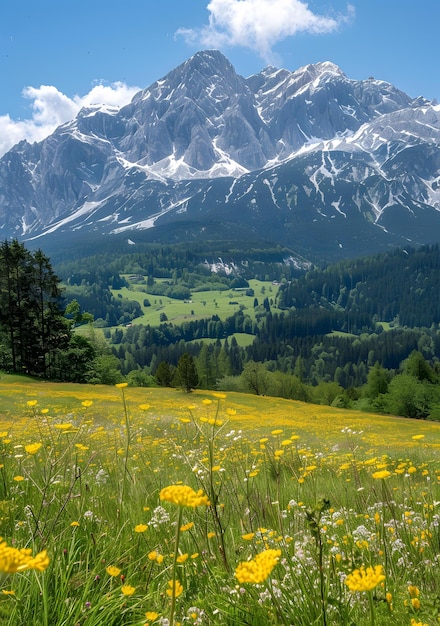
top-left (0, 375), bottom-right (440, 626)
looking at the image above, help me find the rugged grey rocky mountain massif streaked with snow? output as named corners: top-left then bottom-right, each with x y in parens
top-left (0, 50), bottom-right (440, 260)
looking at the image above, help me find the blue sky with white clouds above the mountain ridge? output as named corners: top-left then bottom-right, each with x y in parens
top-left (0, 0), bottom-right (440, 154)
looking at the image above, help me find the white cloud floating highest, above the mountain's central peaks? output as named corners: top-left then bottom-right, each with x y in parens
top-left (177, 0), bottom-right (354, 61)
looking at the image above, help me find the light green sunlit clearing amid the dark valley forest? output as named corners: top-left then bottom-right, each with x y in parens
top-left (112, 280), bottom-right (278, 326)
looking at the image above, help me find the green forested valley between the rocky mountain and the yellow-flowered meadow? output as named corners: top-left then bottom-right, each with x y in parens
top-left (0, 239), bottom-right (440, 419)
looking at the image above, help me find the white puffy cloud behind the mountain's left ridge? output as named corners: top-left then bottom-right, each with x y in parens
top-left (0, 82), bottom-right (139, 156)
